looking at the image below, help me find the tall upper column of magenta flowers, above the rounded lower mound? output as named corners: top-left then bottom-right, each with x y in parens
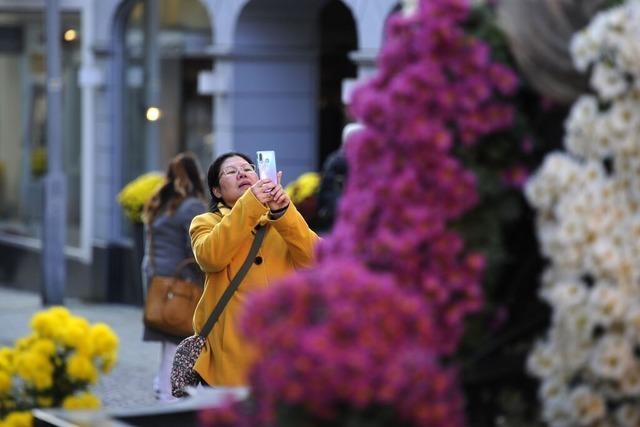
top-left (319, 0), bottom-right (518, 355)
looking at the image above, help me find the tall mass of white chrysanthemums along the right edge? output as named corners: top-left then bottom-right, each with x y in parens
top-left (527, 0), bottom-right (640, 427)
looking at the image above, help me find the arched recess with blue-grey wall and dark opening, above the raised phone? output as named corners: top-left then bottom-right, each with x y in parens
top-left (229, 0), bottom-right (357, 183)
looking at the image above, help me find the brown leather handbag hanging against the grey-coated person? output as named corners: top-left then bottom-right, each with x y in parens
top-left (143, 228), bottom-right (202, 337)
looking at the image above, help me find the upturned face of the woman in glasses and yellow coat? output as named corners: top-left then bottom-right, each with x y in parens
top-left (213, 156), bottom-right (258, 207)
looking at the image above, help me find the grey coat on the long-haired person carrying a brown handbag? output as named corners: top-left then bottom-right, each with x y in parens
top-left (142, 197), bottom-right (207, 343)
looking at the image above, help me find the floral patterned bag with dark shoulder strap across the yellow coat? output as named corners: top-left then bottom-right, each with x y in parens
top-left (171, 226), bottom-right (267, 397)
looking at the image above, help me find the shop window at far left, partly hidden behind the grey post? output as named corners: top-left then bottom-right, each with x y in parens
top-left (0, 13), bottom-right (81, 247)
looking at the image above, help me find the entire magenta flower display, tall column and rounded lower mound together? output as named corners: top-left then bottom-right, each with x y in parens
top-left (202, 0), bottom-right (518, 427)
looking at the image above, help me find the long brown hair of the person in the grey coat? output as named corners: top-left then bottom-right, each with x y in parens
top-left (143, 152), bottom-right (205, 224)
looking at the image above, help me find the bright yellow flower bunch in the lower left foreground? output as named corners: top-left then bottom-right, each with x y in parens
top-left (0, 307), bottom-right (119, 427)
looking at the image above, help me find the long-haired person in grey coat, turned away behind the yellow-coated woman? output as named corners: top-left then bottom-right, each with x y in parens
top-left (142, 153), bottom-right (207, 401)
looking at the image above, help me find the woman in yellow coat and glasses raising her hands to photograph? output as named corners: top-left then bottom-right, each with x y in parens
top-left (189, 153), bottom-right (318, 386)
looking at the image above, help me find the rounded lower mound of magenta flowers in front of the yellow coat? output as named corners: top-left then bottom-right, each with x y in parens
top-left (245, 260), bottom-right (462, 425)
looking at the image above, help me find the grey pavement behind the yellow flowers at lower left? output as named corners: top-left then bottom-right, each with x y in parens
top-left (0, 285), bottom-right (168, 410)
